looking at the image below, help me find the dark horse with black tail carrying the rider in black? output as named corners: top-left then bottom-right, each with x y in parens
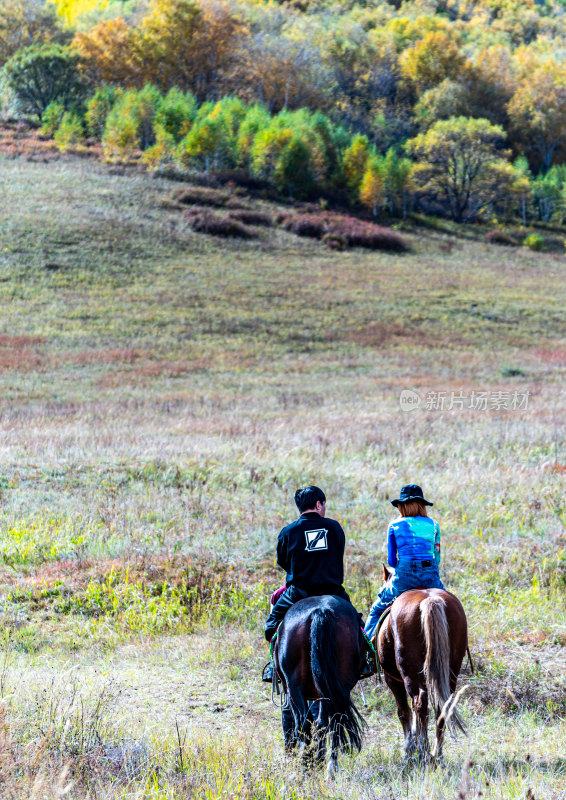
top-left (273, 595), bottom-right (365, 777)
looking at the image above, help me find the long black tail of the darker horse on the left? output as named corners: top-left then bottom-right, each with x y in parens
top-left (311, 608), bottom-right (366, 752)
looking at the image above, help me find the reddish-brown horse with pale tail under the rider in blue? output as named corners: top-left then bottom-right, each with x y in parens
top-left (377, 566), bottom-right (468, 760)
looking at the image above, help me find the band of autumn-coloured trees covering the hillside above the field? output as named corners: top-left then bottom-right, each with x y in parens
top-left (0, 0), bottom-right (566, 222)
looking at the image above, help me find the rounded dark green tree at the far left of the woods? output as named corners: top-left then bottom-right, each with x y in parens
top-left (4, 44), bottom-right (86, 119)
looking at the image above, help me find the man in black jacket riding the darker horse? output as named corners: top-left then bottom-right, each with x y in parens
top-left (262, 486), bottom-right (374, 682)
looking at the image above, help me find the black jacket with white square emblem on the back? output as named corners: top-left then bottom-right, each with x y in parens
top-left (277, 511), bottom-right (346, 594)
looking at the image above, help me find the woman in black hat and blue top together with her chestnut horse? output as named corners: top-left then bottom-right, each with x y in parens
top-left (365, 484), bottom-right (468, 759)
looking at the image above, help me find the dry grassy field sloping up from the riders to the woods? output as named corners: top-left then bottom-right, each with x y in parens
top-left (0, 153), bottom-right (566, 800)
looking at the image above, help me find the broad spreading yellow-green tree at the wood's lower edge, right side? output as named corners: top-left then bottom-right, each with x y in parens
top-left (407, 117), bottom-right (514, 222)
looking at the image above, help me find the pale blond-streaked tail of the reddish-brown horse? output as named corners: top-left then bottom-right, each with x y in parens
top-left (421, 597), bottom-right (466, 733)
